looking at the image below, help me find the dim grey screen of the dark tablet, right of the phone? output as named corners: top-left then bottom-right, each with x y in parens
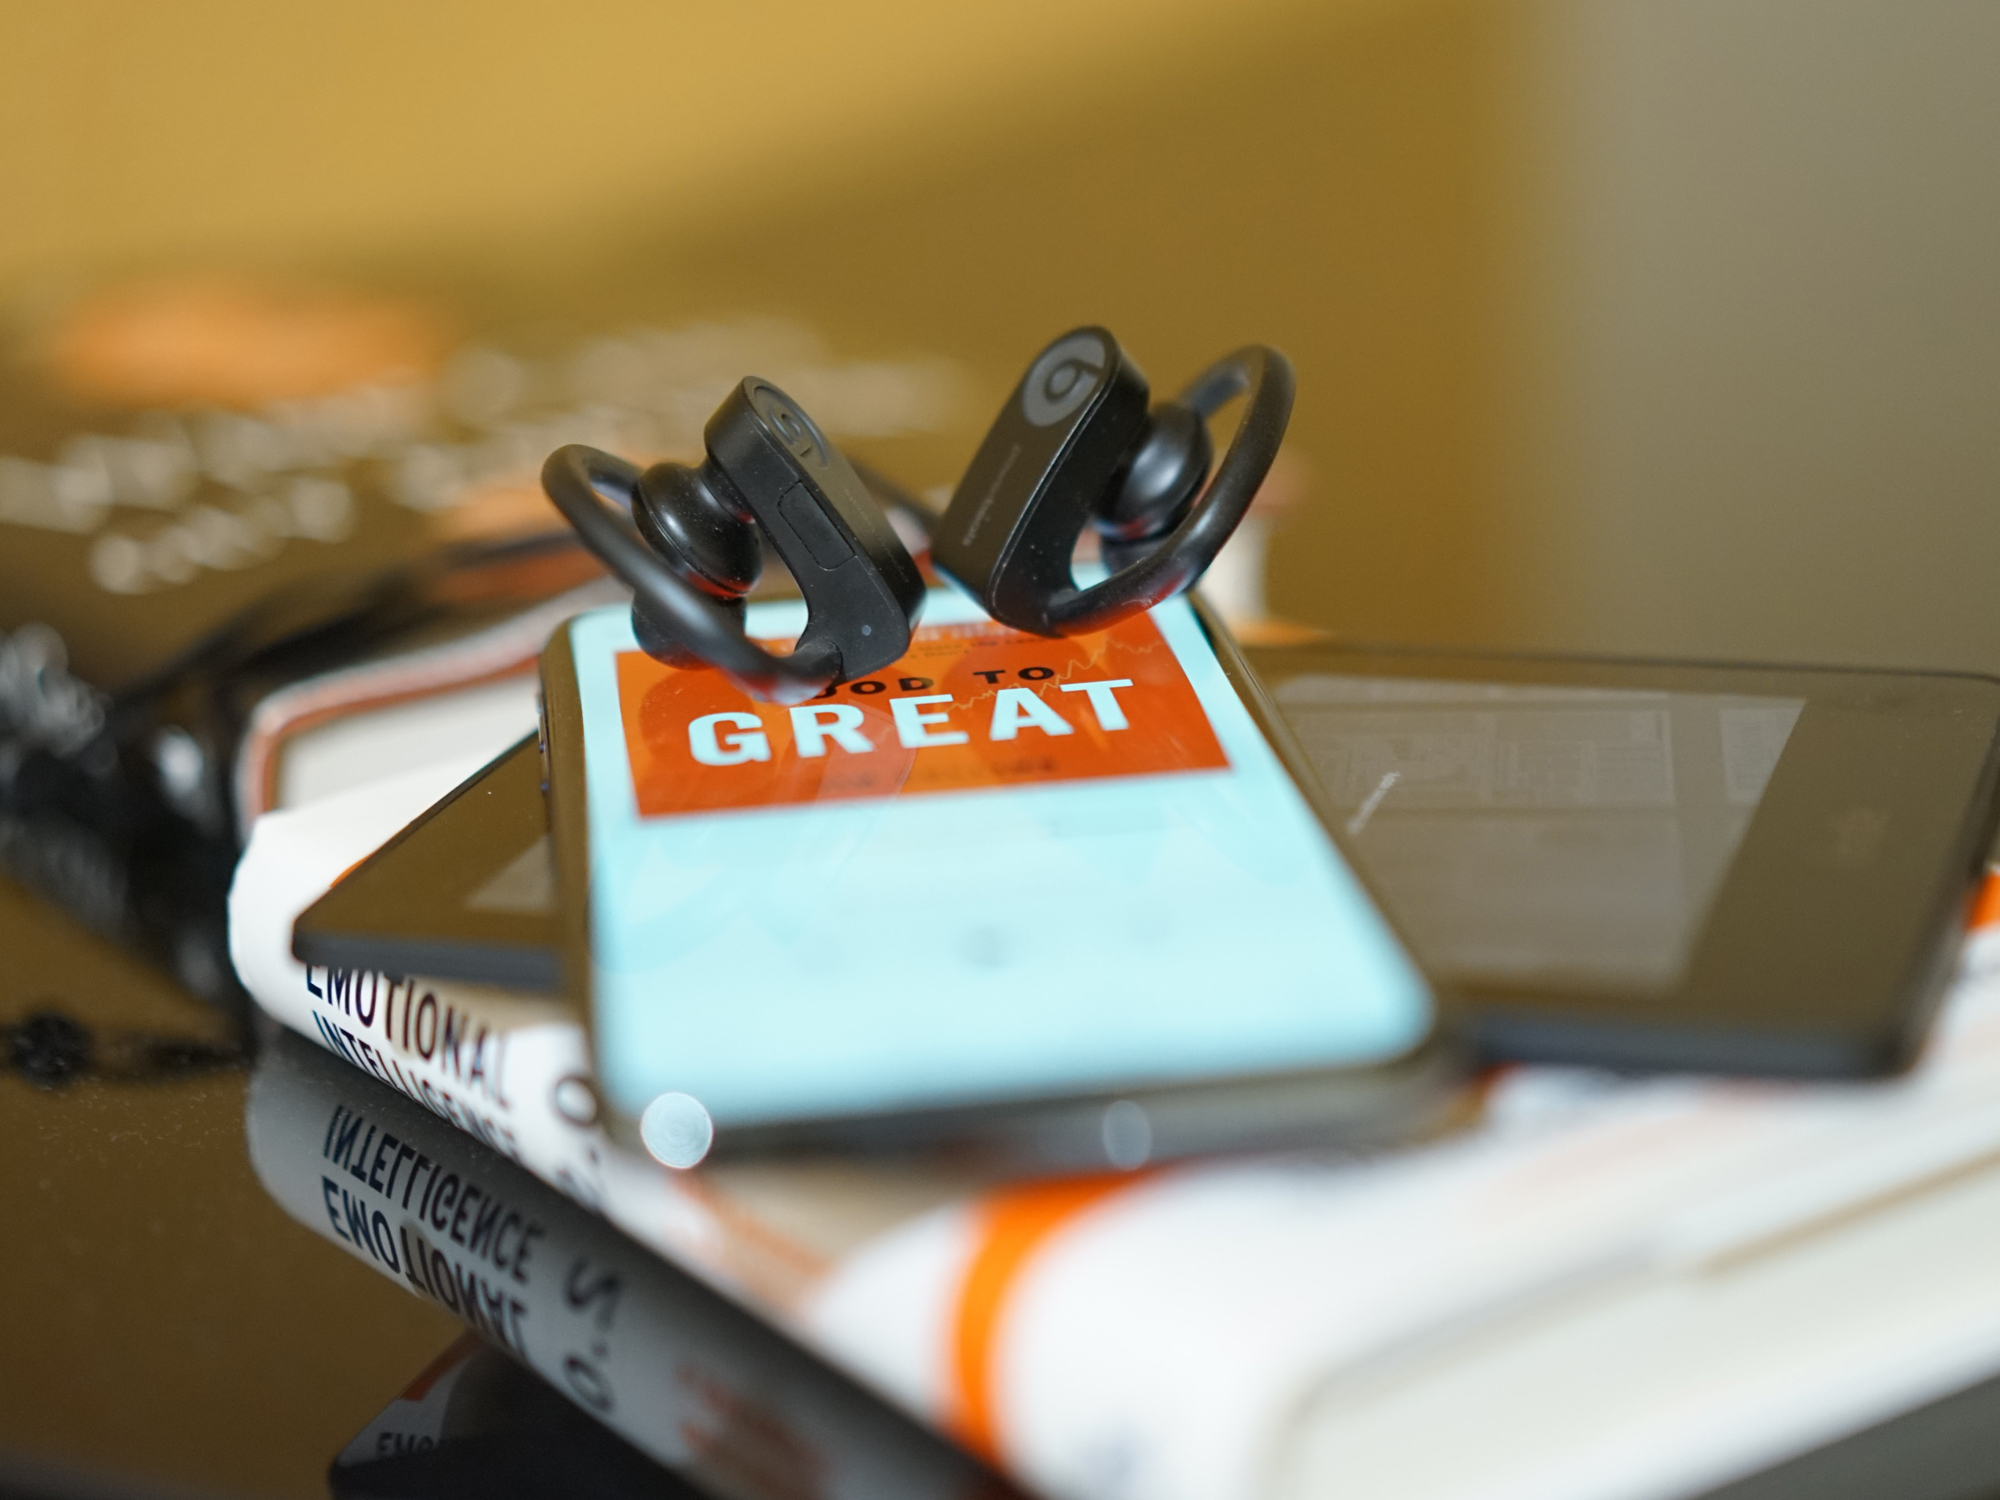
top-left (1270, 672), bottom-right (1806, 992)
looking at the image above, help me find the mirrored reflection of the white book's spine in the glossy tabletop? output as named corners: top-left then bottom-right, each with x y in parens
top-left (244, 1038), bottom-right (1008, 1500)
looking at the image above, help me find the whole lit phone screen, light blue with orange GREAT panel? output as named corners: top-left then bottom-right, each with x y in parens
top-left (568, 590), bottom-right (1432, 1126)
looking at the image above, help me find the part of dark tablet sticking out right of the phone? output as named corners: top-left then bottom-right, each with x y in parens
top-left (1224, 644), bottom-right (2000, 1078)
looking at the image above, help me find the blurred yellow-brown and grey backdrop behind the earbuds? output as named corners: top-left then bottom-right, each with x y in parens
top-left (0, 0), bottom-right (2000, 670)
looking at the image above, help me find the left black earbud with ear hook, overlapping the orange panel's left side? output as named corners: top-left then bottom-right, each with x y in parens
top-left (542, 378), bottom-right (924, 704)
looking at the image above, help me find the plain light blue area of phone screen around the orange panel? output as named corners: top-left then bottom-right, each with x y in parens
top-left (572, 592), bottom-right (1432, 1126)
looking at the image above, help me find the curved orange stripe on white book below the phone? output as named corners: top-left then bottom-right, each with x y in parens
top-left (952, 1172), bottom-right (1144, 1462)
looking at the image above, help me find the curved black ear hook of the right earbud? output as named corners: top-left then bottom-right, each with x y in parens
top-left (1048, 344), bottom-right (1296, 636)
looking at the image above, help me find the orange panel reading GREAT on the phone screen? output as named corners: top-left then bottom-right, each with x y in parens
top-left (618, 614), bottom-right (1228, 818)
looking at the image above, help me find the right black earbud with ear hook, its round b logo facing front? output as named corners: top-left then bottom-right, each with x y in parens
top-left (930, 328), bottom-right (1292, 636)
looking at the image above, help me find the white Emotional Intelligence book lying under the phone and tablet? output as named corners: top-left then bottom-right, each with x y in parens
top-left (232, 748), bottom-right (2000, 1500)
